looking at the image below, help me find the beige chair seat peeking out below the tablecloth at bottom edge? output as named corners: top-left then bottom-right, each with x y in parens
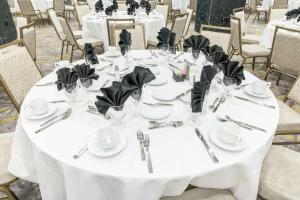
top-left (160, 188), bottom-right (235, 200)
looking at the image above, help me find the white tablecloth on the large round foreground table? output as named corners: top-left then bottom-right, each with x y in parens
top-left (8, 50), bottom-right (279, 200)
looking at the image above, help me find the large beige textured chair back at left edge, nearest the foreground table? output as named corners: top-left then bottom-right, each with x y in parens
top-left (0, 46), bottom-right (42, 112)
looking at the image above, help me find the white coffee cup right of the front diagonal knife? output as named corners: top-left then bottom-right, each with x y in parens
top-left (217, 122), bottom-right (243, 145)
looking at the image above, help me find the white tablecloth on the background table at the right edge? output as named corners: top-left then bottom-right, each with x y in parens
top-left (260, 19), bottom-right (300, 48)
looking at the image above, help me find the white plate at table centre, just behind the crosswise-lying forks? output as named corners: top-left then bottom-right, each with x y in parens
top-left (141, 104), bottom-right (172, 120)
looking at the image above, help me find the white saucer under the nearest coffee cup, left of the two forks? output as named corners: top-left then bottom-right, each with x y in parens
top-left (88, 134), bottom-right (127, 157)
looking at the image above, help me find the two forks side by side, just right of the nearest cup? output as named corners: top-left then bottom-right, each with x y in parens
top-left (137, 130), bottom-right (153, 173)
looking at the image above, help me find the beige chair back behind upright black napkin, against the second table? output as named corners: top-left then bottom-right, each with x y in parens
top-left (114, 24), bottom-right (147, 50)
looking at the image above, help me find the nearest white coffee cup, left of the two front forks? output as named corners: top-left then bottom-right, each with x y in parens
top-left (96, 127), bottom-right (120, 150)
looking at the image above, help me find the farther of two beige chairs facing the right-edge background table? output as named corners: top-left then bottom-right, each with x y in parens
top-left (233, 8), bottom-right (260, 44)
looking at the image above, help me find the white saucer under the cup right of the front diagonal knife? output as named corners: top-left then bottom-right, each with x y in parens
top-left (209, 129), bottom-right (247, 151)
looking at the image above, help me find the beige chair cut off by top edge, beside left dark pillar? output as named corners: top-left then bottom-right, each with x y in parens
top-left (17, 0), bottom-right (45, 24)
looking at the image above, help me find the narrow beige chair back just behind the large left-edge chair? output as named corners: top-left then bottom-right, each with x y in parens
top-left (20, 22), bottom-right (36, 61)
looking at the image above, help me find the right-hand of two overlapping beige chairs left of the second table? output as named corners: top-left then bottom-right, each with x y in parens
top-left (58, 15), bottom-right (104, 62)
